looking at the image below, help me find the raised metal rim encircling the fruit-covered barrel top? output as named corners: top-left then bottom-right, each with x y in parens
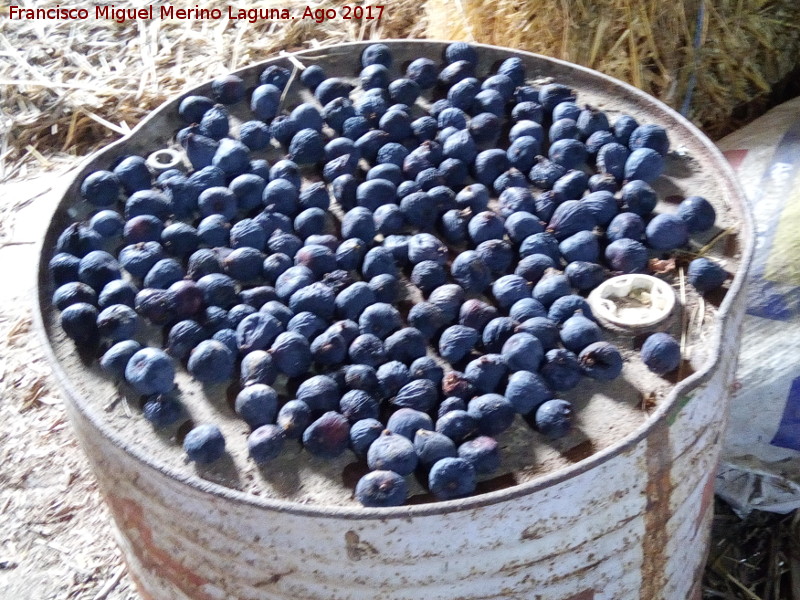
top-left (33, 40), bottom-right (754, 520)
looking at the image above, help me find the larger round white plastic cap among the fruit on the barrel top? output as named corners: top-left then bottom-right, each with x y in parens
top-left (588, 273), bottom-right (675, 329)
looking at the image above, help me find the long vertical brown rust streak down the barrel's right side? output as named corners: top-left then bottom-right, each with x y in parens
top-left (639, 423), bottom-right (672, 600)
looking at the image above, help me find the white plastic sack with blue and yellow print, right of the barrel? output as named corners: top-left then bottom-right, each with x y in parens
top-left (716, 98), bottom-right (800, 514)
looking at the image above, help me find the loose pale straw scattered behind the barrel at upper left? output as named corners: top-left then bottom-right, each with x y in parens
top-left (0, 0), bottom-right (423, 181)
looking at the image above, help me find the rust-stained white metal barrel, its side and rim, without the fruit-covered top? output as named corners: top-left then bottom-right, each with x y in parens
top-left (37, 42), bottom-right (751, 600)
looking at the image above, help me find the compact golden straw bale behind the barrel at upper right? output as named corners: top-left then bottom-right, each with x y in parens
top-left (426, 0), bottom-right (800, 138)
